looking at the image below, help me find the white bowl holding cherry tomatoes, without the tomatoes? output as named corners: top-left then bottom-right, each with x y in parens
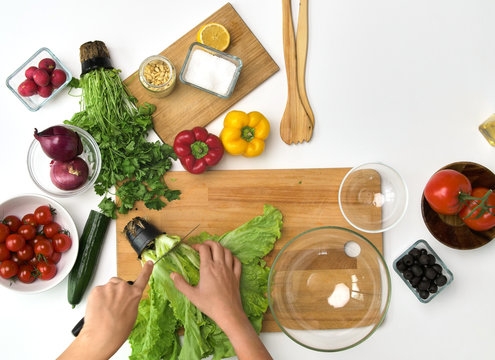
top-left (0, 194), bottom-right (79, 294)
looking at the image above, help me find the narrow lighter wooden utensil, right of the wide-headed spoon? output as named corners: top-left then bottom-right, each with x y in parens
top-left (296, 0), bottom-right (315, 127)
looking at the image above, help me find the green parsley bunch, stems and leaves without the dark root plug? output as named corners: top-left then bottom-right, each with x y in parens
top-left (65, 68), bottom-right (180, 218)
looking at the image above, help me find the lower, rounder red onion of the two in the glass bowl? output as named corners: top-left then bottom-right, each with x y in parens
top-left (50, 157), bottom-right (89, 190)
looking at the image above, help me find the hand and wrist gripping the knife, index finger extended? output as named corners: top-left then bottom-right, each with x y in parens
top-left (59, 261), bottom-right (153, 359)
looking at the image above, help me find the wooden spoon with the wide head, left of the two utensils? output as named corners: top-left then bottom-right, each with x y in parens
top-left (280, 0), bottom-right (313, 144)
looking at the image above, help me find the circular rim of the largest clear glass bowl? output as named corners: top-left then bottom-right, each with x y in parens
top-left (267, 226), bottom-right (392, 352)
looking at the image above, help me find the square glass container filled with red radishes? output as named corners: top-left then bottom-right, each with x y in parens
top-left (6, 48), bottom-right (72, 111)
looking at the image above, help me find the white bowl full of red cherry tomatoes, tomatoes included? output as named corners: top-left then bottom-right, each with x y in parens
top-left (0, 194), bottom-right (79, 293)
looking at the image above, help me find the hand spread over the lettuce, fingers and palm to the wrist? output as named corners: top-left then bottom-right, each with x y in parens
top-left (170, 240), bottom-right (245, 328)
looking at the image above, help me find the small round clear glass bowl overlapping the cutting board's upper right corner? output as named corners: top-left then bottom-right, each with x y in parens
top-left (339, 163), bottom-right (408, 233)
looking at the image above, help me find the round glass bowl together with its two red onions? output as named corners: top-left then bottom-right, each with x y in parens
top-left (27, 124), bottom-right (101, 197)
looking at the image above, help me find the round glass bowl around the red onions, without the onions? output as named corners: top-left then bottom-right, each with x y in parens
top-left (27, 124), bottom-right (101, 197)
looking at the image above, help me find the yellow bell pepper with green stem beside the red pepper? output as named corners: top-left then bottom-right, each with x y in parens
top-left (220, 110), bottom-right (270, 157)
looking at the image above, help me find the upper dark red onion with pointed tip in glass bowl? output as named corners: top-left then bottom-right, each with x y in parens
top-left (34, 125), bottom-right (83, 161)
